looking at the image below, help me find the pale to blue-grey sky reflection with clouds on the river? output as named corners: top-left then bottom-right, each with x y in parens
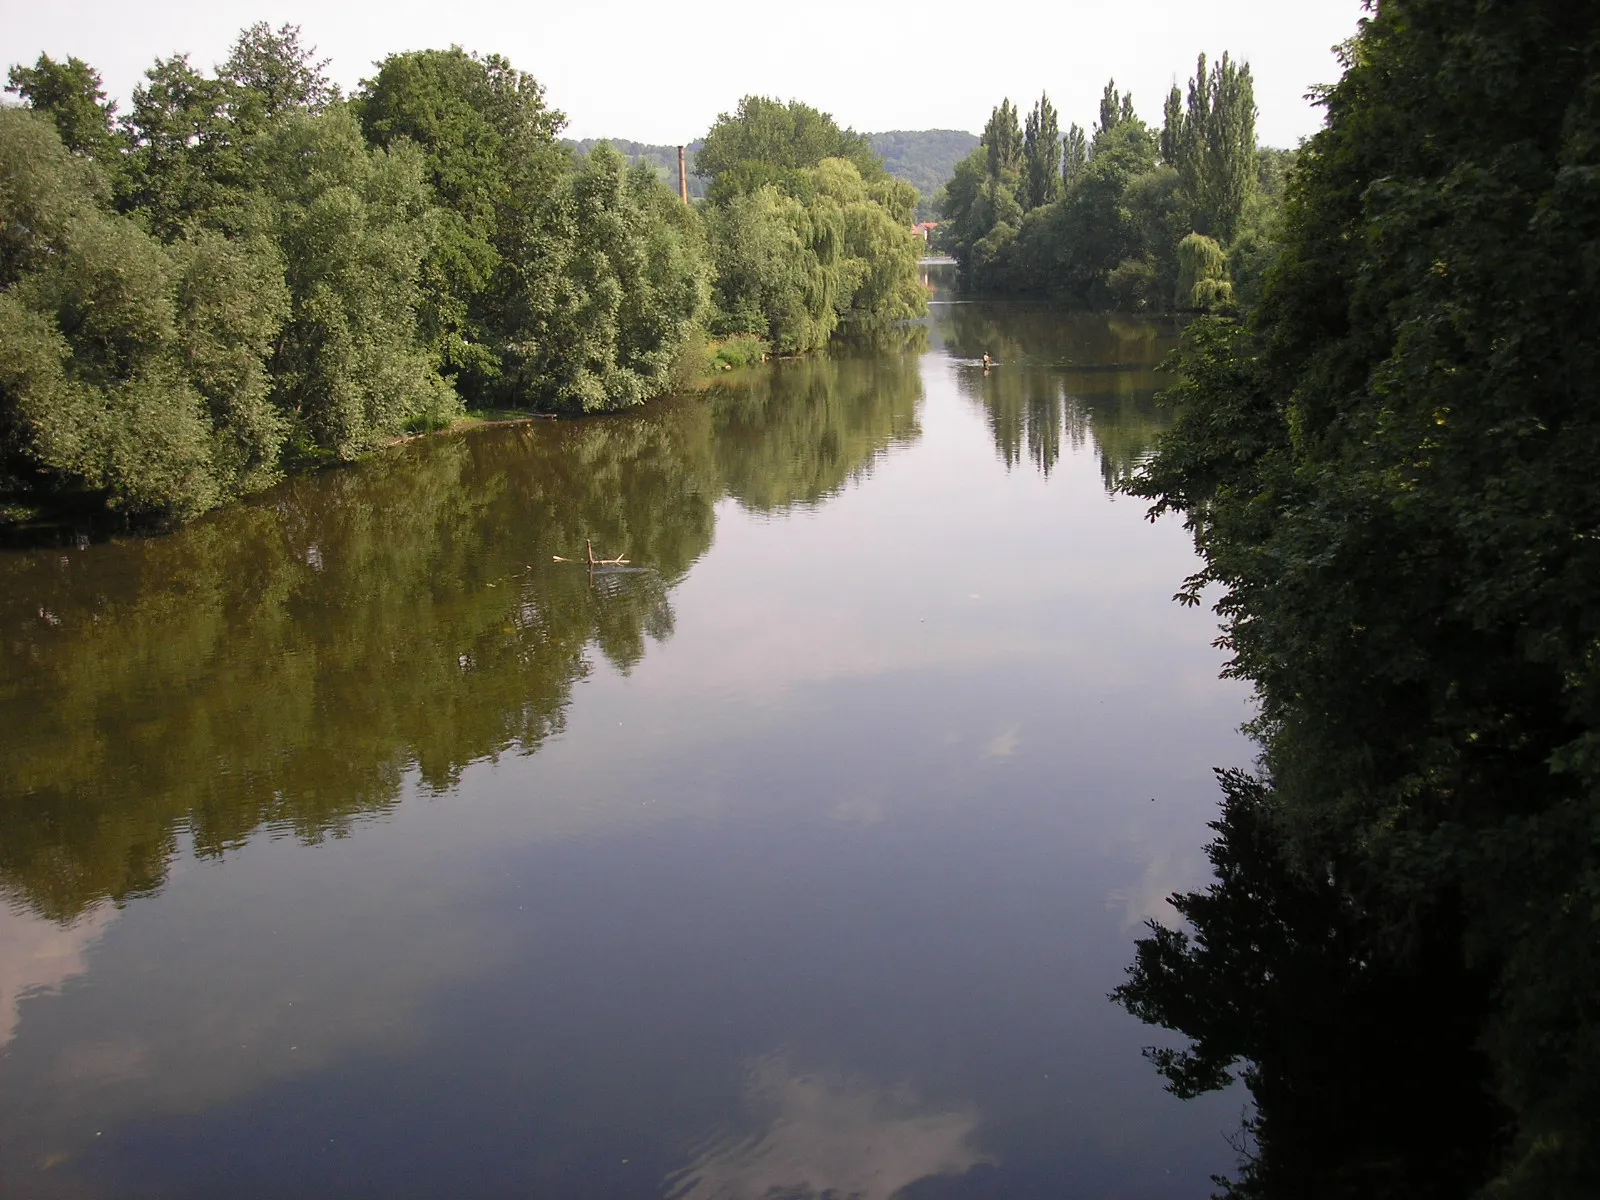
top-left (0, 315), bottom-right (1248, 1200)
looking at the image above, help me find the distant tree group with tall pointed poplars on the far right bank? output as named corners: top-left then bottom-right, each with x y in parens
top-left (939, 54), bottom-right (1293, 310)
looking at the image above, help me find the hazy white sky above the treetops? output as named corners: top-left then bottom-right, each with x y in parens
top-left (0, 0), bottom-right (1362, 146)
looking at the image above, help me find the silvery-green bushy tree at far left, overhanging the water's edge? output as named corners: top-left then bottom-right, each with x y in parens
top-left (0, 109), bottom-right (285, 517)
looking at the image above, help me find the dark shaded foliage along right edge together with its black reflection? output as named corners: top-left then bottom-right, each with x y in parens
top-left (1118, 0), bottom-right (1600, 1200)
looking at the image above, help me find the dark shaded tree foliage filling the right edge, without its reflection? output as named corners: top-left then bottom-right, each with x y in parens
top-left (1120, 0), bottom-right (1600, 1197)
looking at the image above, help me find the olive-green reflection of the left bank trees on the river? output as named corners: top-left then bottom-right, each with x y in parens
top-left (0, 347), bottom-right (922, 923)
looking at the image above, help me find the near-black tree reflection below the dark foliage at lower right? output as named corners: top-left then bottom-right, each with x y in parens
top-left (1112, 771), bottom-right (1507, 1200)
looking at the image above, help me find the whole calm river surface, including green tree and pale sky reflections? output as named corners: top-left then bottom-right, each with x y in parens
top-left (0, 276), bottom-right (1250, 1200)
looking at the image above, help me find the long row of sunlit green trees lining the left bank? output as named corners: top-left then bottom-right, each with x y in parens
top-left (0, 24), bottom-right (925, 518)
